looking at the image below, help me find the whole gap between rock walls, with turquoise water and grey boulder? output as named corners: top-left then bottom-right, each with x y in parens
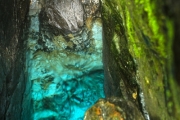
top-left (25, 0), bottom-right (104, 120)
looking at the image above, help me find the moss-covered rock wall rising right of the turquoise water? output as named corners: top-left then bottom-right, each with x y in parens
top-left (102, 0), bottom-right (180, 120)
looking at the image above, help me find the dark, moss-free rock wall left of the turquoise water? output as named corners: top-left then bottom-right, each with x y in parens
top-left (0, 0), bottom-right (29, 120)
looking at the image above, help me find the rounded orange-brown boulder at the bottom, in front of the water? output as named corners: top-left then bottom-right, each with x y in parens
top-left (84, 97), bottom-right (145, 120)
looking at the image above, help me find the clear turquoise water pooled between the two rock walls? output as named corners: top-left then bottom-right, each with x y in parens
top-left (26, 1), bottom-right (104, 120)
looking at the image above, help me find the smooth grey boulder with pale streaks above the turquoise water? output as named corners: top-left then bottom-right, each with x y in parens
top-left (40, 0), bottom-right (84, 33)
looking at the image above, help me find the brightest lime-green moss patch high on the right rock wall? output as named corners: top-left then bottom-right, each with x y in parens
top-left (125, 0), bottom-right (166, 58)
